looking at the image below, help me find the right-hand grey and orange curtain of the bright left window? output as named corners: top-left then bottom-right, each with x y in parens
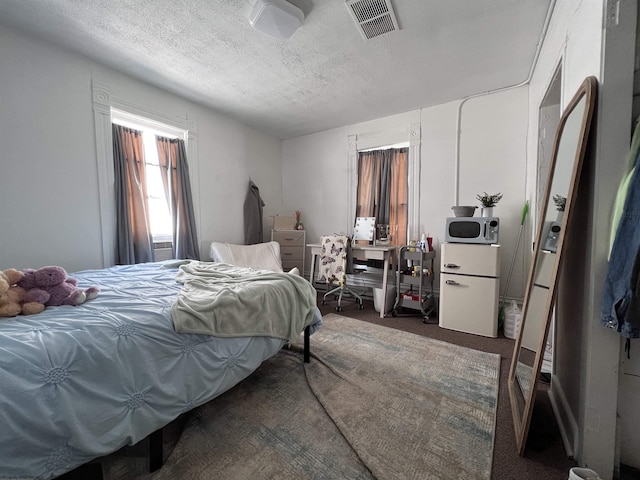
top-left (156, 136), bottom-right (200, 260)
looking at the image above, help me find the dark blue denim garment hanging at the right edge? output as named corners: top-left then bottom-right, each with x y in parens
top-left (600, 138), bottom-right (640, 338)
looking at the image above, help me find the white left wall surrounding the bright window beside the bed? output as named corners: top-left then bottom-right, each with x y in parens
top-left (0, 27), bottom-right (282, 272)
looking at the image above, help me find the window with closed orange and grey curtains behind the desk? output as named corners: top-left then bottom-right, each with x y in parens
top-left (356, 147), bottom-right (409, 245)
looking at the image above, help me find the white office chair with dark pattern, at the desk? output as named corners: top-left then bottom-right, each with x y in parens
top-left (318, 235), bottom-right (364, 312)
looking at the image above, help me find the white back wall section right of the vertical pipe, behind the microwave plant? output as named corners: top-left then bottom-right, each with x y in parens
top-left (456, 87), bottom-right (531, 299)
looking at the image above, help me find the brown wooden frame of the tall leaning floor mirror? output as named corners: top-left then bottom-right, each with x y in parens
top-left (508, 77), bottom-right (597, 456)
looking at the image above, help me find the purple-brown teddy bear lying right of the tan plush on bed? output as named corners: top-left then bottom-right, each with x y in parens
top-left (18, 266), bottom-right (99, 307)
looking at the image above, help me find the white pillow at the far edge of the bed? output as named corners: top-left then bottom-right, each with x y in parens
top-left (209, 242), bottom-right (282, 272)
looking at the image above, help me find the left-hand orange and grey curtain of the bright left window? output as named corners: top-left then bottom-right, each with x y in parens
top-left (112, 124), bottom-right (154, 265)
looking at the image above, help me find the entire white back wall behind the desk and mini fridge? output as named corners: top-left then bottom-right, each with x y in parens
top-left (282, 87), bottom-right (528, 298)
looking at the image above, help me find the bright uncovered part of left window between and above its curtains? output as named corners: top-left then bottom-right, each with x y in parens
top-left (111, 109), bottom-right (186, 244)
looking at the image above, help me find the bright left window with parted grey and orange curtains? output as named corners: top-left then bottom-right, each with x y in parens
top-left (112, 117), bottom-right (198, 264)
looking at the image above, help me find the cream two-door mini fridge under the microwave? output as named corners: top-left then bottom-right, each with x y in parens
top-left (439, 243), bottom-right (500, 337)
